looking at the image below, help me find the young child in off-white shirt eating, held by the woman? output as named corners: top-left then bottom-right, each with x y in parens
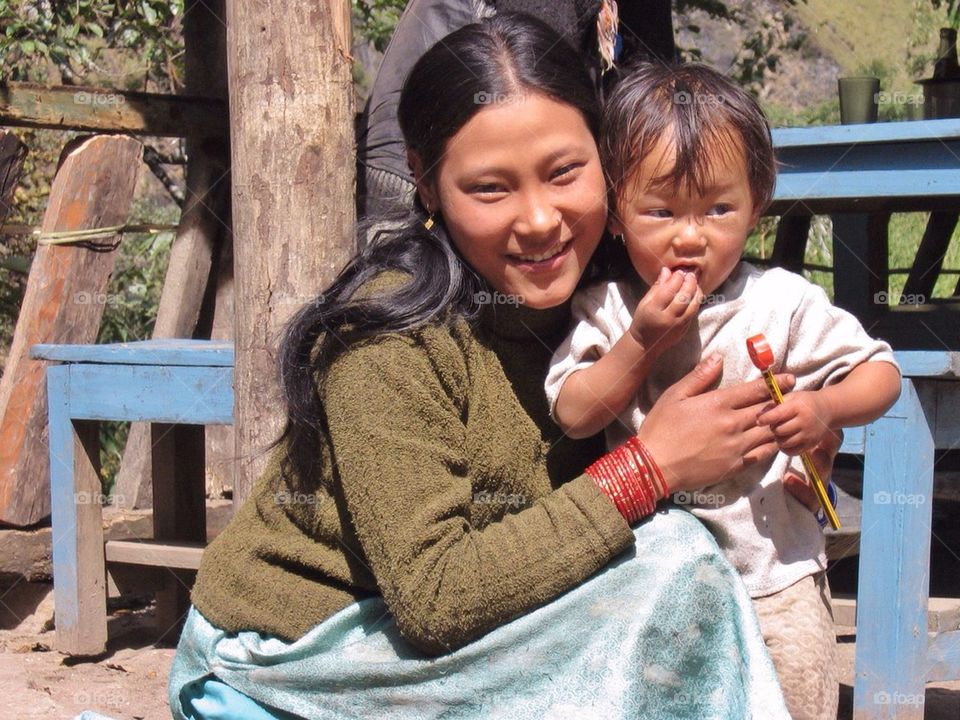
top-left (546, 64), bottom-right (900, 720)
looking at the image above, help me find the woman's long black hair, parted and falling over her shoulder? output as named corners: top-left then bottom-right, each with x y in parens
top-left (278, 13), bottom-right (612, 456)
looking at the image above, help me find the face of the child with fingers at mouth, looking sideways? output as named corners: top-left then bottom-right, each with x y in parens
top-left (610, 136), bottom-right (759, 295)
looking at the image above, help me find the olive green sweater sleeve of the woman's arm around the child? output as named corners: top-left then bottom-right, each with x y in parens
top-left (320, 333), bottom-right (633, 654)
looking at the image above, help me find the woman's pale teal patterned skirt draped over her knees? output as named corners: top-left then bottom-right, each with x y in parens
top-left (170, 508), bottom-right (789, 720)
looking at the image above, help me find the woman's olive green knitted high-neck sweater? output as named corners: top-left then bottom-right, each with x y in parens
top-left (193, 296), bottom-right (633, 654)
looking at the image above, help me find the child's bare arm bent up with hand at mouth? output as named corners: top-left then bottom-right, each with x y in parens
top-left (554, 268), bottom-right (703, 438)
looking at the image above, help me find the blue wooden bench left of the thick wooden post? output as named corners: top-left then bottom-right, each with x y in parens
top-left (31, 340), bottom-right (234, 655)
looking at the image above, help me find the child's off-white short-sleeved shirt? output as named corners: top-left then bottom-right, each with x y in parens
top-left (546, 262), bottom-right (896, 597)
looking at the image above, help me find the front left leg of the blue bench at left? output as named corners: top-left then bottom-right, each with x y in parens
top-left (47, 365), bottom-right (107, 655)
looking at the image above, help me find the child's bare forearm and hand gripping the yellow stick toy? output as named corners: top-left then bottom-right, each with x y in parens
top-left (757, 360), bottom-right (900, 455)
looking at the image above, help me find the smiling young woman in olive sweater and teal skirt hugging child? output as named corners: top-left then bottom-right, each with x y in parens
top-left (170, 13), bottom-right (789, 720)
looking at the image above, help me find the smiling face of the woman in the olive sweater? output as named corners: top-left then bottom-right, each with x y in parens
top-left (414, 93), bottom-right (607, 309)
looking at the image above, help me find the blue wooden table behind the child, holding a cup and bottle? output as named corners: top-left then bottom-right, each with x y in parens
top-left (769, 119), bottom-right (960, 350)
